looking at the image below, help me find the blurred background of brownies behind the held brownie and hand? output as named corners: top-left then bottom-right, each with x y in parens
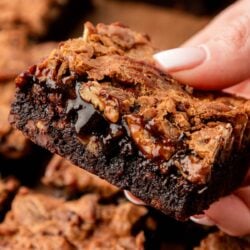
top-left (0, 0), bottom-right (247, 250)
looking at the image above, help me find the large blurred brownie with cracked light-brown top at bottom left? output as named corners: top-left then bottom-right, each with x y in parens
top-left (0, 189), bottom-right (147, 250)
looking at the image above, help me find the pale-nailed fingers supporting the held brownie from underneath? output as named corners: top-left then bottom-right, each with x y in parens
top-left (124, 170), bottom-right (250, 236)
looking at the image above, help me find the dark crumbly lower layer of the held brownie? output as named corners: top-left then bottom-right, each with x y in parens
top-left (10, 76), bottom-right (248, 220)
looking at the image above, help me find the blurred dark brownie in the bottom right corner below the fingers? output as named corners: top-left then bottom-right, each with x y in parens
top-left (194, 231), bottom-right (250, 250)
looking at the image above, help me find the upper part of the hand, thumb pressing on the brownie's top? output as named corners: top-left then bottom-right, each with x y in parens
top-left (154, 0), bottom-right (250, 98)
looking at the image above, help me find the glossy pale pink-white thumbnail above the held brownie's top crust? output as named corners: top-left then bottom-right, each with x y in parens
top-left (154, 46), bottom-right (208, 72)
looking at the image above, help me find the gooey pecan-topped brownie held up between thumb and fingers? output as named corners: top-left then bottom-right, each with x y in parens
top-left (10, 23), bottom-right (250, 220)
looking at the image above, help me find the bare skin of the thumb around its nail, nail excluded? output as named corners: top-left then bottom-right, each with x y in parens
top-left (170, 0), bottom-right (250, 91)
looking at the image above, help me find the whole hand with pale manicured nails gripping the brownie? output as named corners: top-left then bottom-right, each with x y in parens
top-left (125, 0), bottom-right (250, 236)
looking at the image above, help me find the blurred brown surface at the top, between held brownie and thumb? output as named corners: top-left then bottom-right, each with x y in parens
top-left (71, 0), bottom-right (233, 49)
